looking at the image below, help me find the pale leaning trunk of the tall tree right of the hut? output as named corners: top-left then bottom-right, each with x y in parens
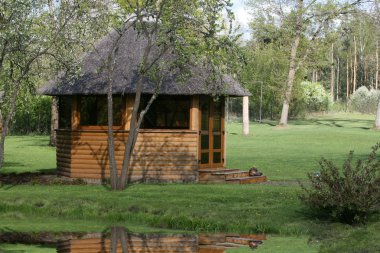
top-left (280, 0), bottom-right (303, 126)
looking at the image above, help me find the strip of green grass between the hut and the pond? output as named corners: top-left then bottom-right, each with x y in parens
top-left (0, 184), bottom-right (309, 234)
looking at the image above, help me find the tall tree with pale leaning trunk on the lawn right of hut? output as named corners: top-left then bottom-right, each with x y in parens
top-left (250, 0), bottom-right (366, 126)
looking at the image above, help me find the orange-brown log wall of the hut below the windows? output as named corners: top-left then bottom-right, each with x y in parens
top-left (57, 130), bottom-right (198, 182)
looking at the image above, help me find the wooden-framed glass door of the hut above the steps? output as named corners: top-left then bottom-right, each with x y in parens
top-left (199, 96), bottom-right (224, 168)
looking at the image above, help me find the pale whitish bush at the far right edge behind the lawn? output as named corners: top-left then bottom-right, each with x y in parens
top-left (350, 86), bottom-right (380, 113)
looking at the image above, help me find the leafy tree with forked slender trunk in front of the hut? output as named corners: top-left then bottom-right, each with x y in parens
top-left (99, 0), bottom-right (239, 190)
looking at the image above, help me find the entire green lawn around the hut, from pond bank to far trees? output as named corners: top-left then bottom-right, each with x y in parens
top-left (0, 114), bottom-right (380, 252)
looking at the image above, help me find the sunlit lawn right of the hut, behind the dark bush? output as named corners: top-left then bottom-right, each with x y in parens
top-left (227, 114), bottom-right (380, 180)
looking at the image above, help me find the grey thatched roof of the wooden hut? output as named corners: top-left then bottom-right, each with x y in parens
top-left (39, 25), bottom-right (251, 96)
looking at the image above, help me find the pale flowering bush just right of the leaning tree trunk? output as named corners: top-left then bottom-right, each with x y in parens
top-left (301, 81), bottom-right (330, 112)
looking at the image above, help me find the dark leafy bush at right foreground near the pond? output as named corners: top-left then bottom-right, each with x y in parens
top-left (300, 143), bottom-right (380, 224)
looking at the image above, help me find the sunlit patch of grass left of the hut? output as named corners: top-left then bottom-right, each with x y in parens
top-left (1, 136), bottom-right (56, 173)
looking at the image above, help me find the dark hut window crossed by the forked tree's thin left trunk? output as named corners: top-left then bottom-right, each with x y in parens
top-left (79, 96), bottom-right (123, 126)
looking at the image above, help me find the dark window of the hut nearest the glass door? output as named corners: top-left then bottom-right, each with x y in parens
top-left (140, 96), bottom-right (190, 129)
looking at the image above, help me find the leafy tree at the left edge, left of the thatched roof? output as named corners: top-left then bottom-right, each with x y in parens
top-left (0, 0), bottom-right (113, 168)
